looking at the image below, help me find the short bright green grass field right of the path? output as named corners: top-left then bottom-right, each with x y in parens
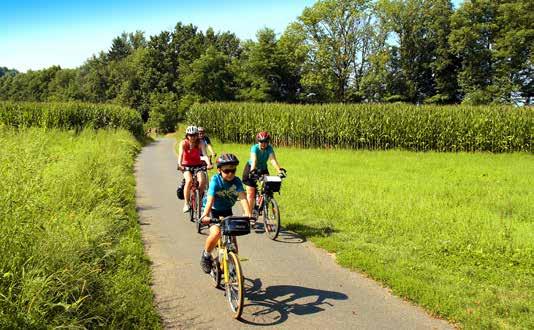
top-left (214, 144), bottom-right (534, 329)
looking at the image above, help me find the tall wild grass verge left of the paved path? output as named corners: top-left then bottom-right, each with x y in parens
top-left (0, 127), bottom-right (160, 329)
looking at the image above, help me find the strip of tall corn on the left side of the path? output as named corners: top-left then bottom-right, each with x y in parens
top-left (0, 101), bottom-right (143, 136)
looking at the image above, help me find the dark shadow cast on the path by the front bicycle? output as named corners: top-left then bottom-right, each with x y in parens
top-left (241, 278), bottom-right (348, 326)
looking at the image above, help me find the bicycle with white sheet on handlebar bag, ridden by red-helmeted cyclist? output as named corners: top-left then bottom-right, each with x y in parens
top-left (252, 171), bottom-right (286, 240)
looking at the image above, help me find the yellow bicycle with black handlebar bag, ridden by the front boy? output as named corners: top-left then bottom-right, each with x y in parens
top-left (210, 216), bottom-right (250, 319)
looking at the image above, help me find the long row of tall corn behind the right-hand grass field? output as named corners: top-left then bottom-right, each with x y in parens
top-left (187, 103), bottom-right (534, 152)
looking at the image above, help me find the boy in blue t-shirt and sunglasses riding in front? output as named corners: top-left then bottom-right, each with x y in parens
top-left (200, 154), bottom-right (251, 273)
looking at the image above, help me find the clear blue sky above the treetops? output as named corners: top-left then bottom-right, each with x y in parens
top-left (0, 0), bottom-right (461, 72)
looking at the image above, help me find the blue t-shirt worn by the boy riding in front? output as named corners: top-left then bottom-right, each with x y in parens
top-left (208, 173), bottom-right (245, 211)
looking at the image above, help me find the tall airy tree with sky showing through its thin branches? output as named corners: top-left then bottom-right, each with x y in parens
top-left (298, 0), bottom-right (373, 102)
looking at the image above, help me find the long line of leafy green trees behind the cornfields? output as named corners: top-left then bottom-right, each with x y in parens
top-left (0, 0), bottom-right (534, 130)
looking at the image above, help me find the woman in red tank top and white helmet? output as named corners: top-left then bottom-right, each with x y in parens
top-left (178, 126), bottom-right (213, 213)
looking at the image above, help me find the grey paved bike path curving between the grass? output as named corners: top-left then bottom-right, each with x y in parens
top-left (135, 138), bottom-right (452, 329)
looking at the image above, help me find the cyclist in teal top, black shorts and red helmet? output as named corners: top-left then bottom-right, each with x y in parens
top-left (243, 131), bottom-right (286, 210)
